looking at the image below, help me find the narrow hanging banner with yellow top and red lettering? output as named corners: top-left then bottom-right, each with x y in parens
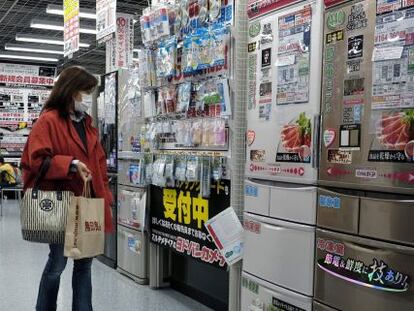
top-left (63, 0), bottom-right (80, 58)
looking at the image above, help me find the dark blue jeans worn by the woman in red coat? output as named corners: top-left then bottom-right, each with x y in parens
top-left (36, 244), bottom-right (92, 311)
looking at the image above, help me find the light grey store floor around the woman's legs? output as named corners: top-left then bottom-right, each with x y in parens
top-left (0, 201), bottom-right (210, 311)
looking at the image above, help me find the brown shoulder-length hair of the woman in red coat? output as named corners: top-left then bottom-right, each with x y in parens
top-left (43, 66), bottom-right (98, 117)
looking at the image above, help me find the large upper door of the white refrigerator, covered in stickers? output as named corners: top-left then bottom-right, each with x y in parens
top-left (246, 0), bottom-right (323, 184)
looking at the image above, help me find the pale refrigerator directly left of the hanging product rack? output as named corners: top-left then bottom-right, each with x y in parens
top-left (117, 69), bottom-right (149, 284)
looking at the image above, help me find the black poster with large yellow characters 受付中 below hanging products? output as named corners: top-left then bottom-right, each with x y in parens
top-left (150, 180), bottom-right (230, 267)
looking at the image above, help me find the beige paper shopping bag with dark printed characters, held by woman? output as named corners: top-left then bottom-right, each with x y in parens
top-left (64, 183), bottom-right (105, 259)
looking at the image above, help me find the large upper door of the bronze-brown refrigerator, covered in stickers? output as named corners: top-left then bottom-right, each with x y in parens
top-left (319, 0), bottom-right (414, 194)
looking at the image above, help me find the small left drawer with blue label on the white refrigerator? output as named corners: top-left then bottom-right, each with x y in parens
top-left (244, 180), bottom-right (270, 216)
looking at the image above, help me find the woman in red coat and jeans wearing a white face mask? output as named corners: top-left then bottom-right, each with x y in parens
top-left (22, 67), bottom-right (113, 311)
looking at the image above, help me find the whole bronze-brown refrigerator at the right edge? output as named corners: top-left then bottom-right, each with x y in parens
top-left (315, 0), bottom-right (414, 311)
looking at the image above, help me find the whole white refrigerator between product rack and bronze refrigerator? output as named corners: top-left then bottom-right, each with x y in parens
top-left (242, 1), bottom-right (323, 311)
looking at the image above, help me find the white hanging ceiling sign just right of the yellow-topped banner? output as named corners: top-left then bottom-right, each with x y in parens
top-left (96, 0), bottom-right (116, 40)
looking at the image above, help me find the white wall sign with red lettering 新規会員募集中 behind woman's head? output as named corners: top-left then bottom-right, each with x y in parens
top-left (0, 63), bottom-right (56, 86)
